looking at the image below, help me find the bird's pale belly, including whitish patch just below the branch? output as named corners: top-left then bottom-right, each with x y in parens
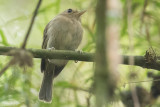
top-left (47, 18), bottom-right (83, 66)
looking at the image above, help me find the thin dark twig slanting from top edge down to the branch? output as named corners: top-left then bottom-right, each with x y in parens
top-left (21, 0), bottom-right (42, 49)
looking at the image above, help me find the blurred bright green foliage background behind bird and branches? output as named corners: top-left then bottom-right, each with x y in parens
top-left (0, 0), bottom-right (160, 107)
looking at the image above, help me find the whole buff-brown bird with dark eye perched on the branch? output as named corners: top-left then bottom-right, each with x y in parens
top-left (39, 8), bottom-right (86, 103)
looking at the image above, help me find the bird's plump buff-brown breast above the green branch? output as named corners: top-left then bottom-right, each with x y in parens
top-left (49, 17), bottom-right (83, 50)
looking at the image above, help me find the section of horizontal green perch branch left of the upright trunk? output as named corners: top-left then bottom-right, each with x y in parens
top-left (0, 46), bottom-right (94, 62)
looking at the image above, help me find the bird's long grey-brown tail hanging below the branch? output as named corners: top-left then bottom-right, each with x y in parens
top-left (39, 66), bottom-right (54, 102)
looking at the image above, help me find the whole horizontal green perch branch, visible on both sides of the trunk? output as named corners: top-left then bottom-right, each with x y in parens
top-left (0, 46), bottom-right (160, 70)
